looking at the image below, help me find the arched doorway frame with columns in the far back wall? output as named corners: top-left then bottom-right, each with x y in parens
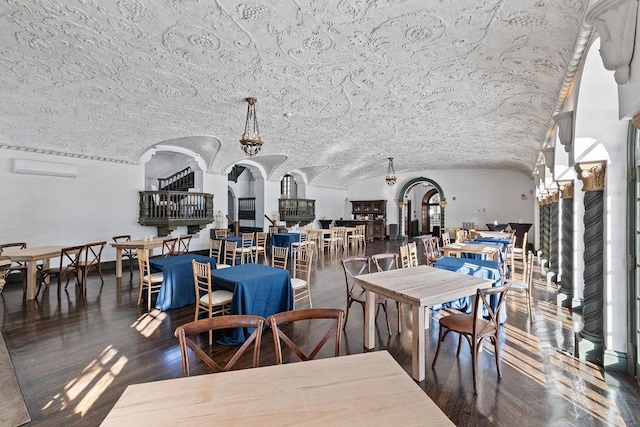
top-left (396, 177), bottom-right (447, 236)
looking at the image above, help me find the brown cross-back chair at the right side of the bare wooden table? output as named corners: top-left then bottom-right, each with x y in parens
top-left (431, 284), bottom-right (509, 394)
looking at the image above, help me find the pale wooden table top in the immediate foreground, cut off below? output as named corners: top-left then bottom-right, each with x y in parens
top-left (102, 351), bottom-right (454, 427)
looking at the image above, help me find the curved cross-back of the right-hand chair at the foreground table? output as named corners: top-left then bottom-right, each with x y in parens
top-left (267, 308), bottom-right (344, 365)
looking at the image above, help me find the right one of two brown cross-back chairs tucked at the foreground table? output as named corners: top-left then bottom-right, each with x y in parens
top-left (267, 308), bottom-right (344, 365)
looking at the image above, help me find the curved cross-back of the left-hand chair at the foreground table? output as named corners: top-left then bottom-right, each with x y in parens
top-left (175, 314), bottom-right (265, 377)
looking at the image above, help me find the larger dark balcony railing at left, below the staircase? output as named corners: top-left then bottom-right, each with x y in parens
top-left (138, 191), bottom-right (214, 236)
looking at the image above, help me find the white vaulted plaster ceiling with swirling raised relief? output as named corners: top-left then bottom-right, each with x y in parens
top-left (0, 0), bottom-right (587, 187)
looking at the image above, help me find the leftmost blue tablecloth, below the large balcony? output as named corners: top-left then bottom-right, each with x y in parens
top-left (149, 254), bottom-right (216, 311)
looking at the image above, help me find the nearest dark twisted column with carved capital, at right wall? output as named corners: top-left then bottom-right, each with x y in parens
top-left (575, 161), bottom-right (606, 366)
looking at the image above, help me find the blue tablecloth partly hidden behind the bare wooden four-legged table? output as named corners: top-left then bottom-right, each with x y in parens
top-left (432, 257), bottom-right (507, 323)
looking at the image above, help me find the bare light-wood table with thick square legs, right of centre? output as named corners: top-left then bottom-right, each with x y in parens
top-left (355, 265), bottom-right (493, 381)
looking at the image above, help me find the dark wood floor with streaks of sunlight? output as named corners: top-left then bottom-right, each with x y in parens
top-left (0, 241), bottom-right (640, 426)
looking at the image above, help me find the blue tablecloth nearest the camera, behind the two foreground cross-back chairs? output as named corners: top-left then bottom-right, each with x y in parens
top-left (211, 264), bottom-right (293, 345)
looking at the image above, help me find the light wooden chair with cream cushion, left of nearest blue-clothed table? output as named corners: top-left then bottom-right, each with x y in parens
top-left (191, 259), bottom-right (233, 345)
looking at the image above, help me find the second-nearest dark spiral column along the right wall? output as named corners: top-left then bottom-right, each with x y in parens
top-left (558, 180), bottom-right (573, 308)
